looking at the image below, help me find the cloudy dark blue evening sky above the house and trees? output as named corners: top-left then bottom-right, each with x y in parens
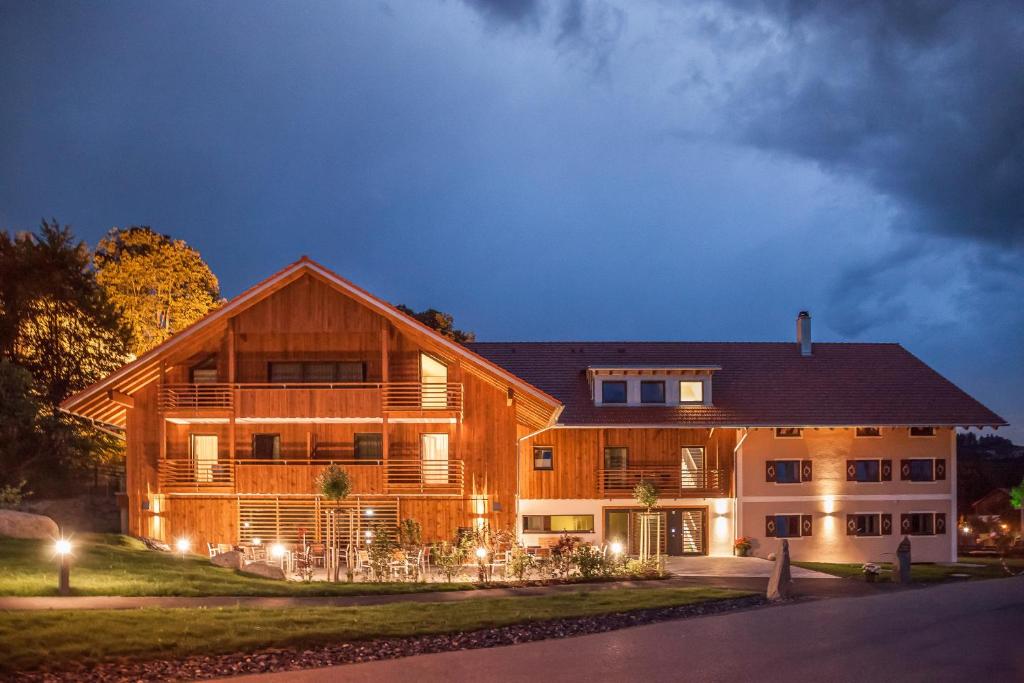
top-left (0, 0), bottom-right (1024, 441)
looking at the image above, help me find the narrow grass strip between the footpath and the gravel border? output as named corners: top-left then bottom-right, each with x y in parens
top-left (0, 588), bottom-right (753, 671)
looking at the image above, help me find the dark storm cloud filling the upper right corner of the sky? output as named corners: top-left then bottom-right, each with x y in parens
top-left (727, 0), bottom-right (1024, 248)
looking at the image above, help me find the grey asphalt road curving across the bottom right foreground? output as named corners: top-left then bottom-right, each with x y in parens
top-left (232, 578), bottom-right (1024, 683)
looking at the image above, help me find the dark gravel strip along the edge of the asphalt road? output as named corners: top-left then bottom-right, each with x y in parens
top-left (12, 595), bottom-right (766, 683)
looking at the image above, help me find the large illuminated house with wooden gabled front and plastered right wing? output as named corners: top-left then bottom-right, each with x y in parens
top-left (63, 258), bottom-right (1005, 560)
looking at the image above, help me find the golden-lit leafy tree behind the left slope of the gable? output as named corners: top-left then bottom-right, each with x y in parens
top-left (93, 226), bottom-right (220, 355)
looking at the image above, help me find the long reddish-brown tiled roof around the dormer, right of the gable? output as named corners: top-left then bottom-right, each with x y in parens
top-left (469, 342), bottom-right (1007, 427)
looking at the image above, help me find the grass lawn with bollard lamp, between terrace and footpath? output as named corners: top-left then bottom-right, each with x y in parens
top-left (0, 535), bottom-right (473, 596)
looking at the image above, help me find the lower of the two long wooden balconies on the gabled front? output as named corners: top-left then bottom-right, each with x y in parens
top-left (158, 458), bottom-right (466, 497)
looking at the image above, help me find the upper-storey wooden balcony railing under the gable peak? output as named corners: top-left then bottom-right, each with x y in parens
top-left (158, 382), bottom-right (463, 418)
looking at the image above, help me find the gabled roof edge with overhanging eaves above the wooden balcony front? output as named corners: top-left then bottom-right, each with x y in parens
top-left (60, 256), bottom-right (560, 427)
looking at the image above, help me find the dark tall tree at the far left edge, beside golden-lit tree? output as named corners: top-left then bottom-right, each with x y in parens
top-left (0, 221), bottom-right (130, 493)
